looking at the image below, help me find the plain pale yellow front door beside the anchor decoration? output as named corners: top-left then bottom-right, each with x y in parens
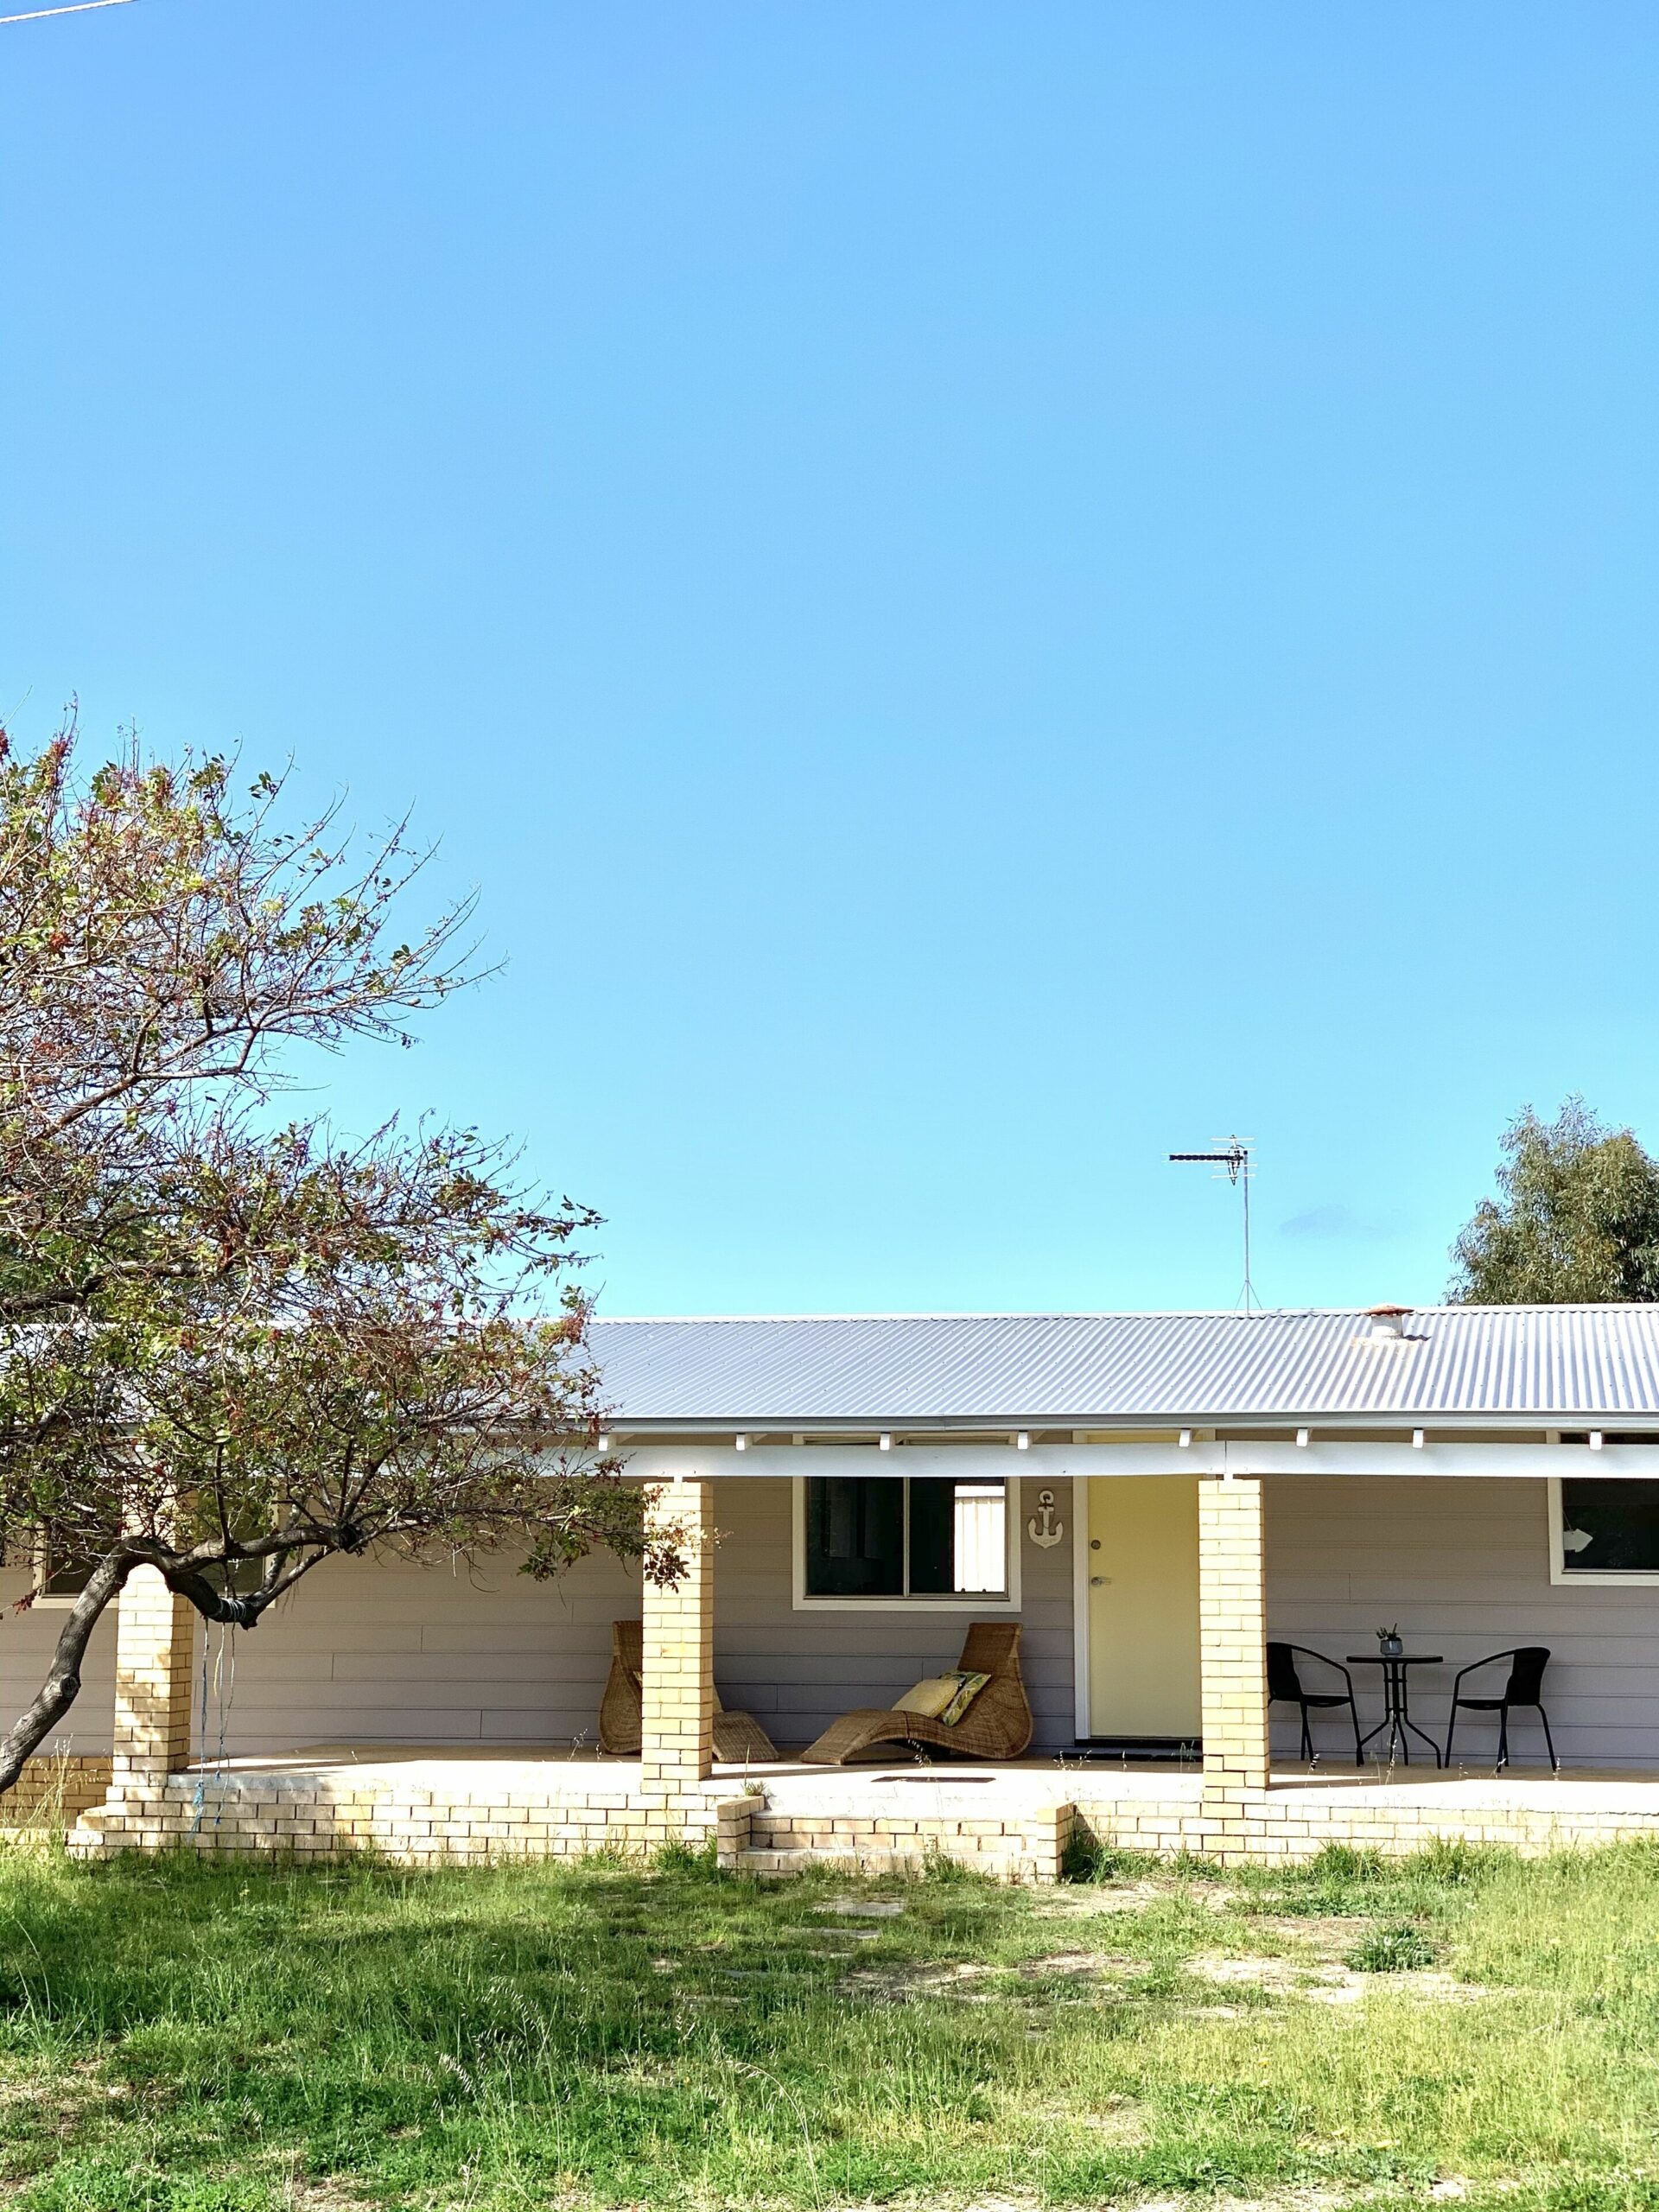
top-left (1089, 1476), bottom-right (1199, 1738)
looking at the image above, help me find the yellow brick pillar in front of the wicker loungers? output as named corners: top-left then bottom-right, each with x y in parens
top-left (639, 1478), bottom-right (715, 1840)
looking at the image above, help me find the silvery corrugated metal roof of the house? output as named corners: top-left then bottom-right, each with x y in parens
top-left (593, 1305), bottom-right (1659, 1429)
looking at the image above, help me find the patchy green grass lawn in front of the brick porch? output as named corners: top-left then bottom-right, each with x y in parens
top-left (0, 1845), bottom-right (1659, 2212)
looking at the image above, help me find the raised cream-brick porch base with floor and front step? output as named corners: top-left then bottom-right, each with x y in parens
top-left (55, 1743), bottom-right (1659, 1883)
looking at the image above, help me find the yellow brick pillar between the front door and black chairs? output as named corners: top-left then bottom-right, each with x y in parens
top-left (1199, 1476), bottom-right (1268, 1858)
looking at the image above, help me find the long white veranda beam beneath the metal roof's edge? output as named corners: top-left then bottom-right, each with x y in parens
top-left (626, 1440), bottom-right (1659, 1482)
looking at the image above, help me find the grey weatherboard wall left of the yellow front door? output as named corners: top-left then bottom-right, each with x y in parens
top-left (0, 1480), bottom-right (1073, 1757)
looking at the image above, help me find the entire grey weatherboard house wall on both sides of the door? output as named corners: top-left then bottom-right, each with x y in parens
top-left (0, 1453), bottom-right (1659, 1767)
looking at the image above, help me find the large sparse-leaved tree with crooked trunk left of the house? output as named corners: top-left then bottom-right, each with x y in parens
top-left (0, 723), bottom-right (679, 1789)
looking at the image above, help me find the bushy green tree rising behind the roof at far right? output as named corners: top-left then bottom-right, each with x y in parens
top-left (1449, 1097), bottom-right (1659, 1305)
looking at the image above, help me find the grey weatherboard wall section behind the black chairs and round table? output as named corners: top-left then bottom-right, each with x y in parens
top-left (1268, 1476), bottom-right (1659, 1767)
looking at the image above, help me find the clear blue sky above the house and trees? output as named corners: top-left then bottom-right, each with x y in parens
top-left (0, 0), bottom-right (1659, 1312)
